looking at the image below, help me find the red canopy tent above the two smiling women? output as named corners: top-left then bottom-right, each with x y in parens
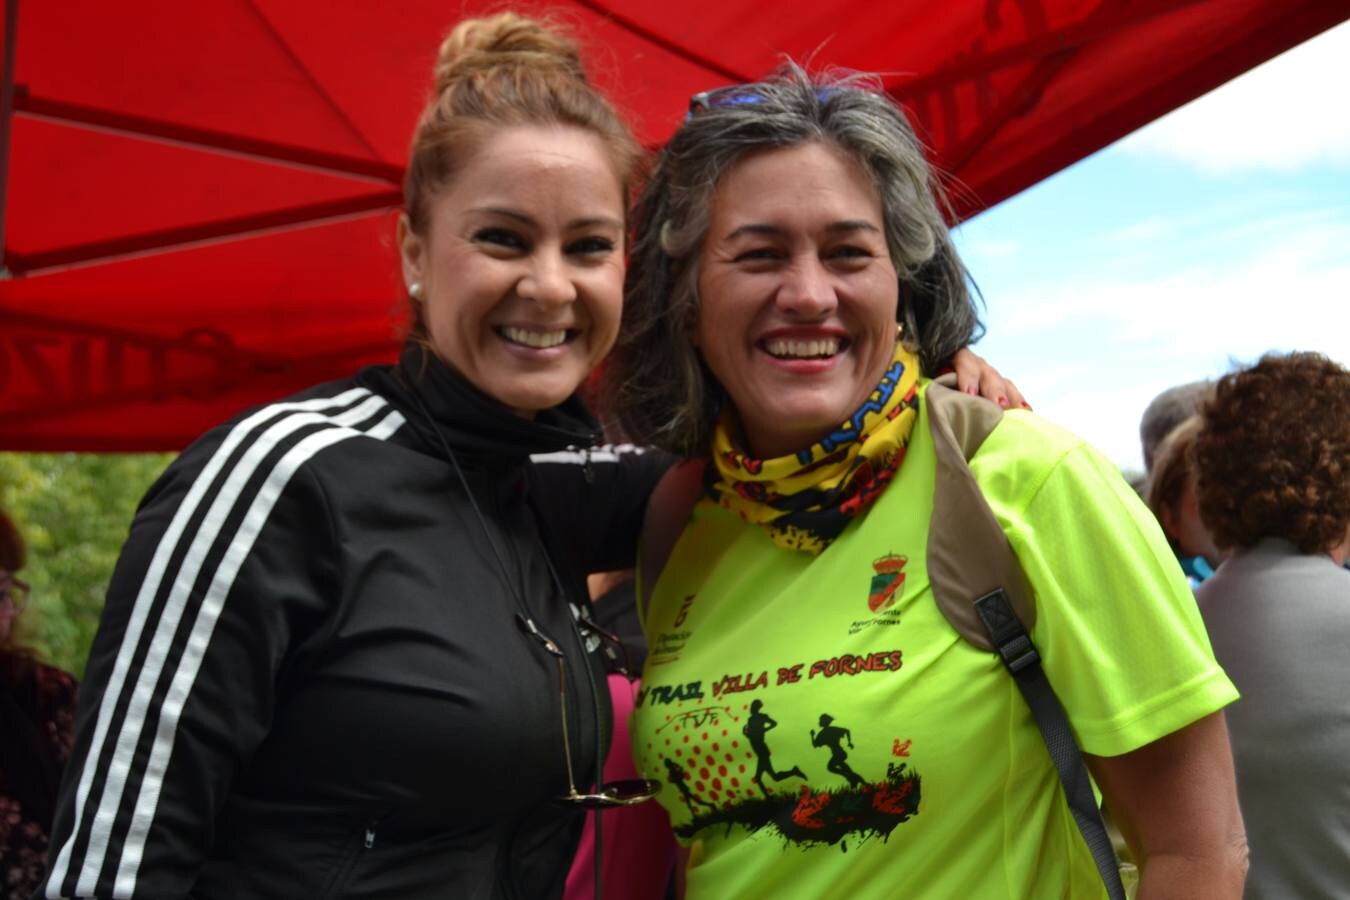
top-left (0, 0), bottom-right (1350, 451)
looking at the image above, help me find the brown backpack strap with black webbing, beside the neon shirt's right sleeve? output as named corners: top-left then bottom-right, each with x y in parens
top-left (925, 376), bottom-right (1125, 900)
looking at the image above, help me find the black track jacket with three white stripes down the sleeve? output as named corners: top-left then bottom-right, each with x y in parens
top-left (45, 348), bottom-right (668, 900)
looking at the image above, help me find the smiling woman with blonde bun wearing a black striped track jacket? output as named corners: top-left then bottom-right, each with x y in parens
top-left (36, 13), bottom-right (667, 900)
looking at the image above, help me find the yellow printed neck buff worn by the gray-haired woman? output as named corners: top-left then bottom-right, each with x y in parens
top-left (707, 344), bottom-right (919, 555)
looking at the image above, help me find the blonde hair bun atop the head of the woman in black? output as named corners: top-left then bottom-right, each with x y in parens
top-left (435, 12), bottom-right (586, 93)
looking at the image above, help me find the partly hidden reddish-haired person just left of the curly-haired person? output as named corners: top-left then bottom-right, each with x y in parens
top-left (1145, 416), bottom-right (1223, 588)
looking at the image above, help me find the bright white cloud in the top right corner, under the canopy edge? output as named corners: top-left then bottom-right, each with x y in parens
top-left (1118, 23), bottom-right (1350, 174)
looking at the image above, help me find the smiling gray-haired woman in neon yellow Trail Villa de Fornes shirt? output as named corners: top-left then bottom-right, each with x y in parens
top-left (612, 63), bottom-right (1245, 900)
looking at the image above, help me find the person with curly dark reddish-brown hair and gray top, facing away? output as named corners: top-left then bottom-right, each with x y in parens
top-left (1195, 354), bottom-right (1350, 900)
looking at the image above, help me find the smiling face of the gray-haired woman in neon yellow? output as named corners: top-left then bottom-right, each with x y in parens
top-left (697, 143), bottom-right (899, 459)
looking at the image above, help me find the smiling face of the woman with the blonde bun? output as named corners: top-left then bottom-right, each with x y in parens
top-left (398, 125), bottom-right (624, 417)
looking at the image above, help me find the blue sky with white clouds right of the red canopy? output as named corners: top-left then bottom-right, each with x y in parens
top-left (956, 23), bottom-right (1350, 471)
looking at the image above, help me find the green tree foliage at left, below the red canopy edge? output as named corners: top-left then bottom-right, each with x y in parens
top-left (0, 453), bottom-right (173, 676)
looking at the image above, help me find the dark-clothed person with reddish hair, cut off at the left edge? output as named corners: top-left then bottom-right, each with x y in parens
top-left (0, 510), bottom-right (76, 900)
